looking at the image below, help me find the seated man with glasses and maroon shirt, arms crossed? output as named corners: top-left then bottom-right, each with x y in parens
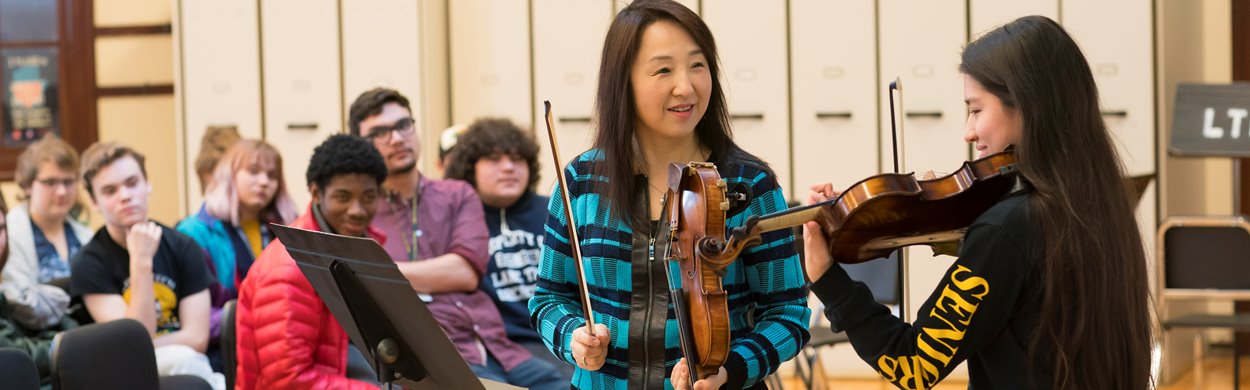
top-left (348, 89), bottom-right (568, 389)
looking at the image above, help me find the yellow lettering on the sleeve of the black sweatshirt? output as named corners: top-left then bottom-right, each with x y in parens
top-left (876, 265), bottom-right (990, 390)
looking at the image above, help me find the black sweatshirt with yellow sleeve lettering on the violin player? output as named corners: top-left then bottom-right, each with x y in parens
top-left (811, 193), bottom-right (1048, 389)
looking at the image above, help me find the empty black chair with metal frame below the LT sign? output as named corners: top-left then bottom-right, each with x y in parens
top-left (1156, 216), bottom-right (1250, 389)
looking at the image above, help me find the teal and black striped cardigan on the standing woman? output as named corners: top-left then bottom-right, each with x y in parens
top-left (530, 150), bottom-right (811, 389)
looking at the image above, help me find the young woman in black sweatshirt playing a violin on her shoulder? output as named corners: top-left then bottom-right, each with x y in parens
top-left (804, 16), bottom-right (1151, 389)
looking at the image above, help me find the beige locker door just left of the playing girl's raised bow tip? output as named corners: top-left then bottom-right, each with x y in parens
top-left (790, 0), bottom-right (883, 201)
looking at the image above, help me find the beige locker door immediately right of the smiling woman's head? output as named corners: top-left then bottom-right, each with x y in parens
top-left (703, 0), bottom-right (794, 198)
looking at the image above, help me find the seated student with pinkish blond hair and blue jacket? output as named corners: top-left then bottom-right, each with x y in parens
top-left (178, 140), bottom-right (295, 366)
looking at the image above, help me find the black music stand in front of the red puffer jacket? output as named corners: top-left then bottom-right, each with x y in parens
top-left (270, 224), bottom-right (519, 390)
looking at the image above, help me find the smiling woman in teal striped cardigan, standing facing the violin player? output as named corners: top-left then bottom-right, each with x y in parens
top-left (530, 0), bottom-right (810, 389)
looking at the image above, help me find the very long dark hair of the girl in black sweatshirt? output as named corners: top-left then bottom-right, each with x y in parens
top-left (959, 16), bottom-right (1153, 389)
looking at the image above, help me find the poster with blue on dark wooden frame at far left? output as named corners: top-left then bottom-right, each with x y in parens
top-left (0, 48), bottom-right (60, 148)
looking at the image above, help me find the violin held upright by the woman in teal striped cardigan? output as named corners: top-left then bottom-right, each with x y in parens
top-left (653, 163), bottom-right (759, 385)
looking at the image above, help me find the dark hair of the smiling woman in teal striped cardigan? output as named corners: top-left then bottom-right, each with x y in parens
top-left (594, 0), bottom-right (766, 223)
